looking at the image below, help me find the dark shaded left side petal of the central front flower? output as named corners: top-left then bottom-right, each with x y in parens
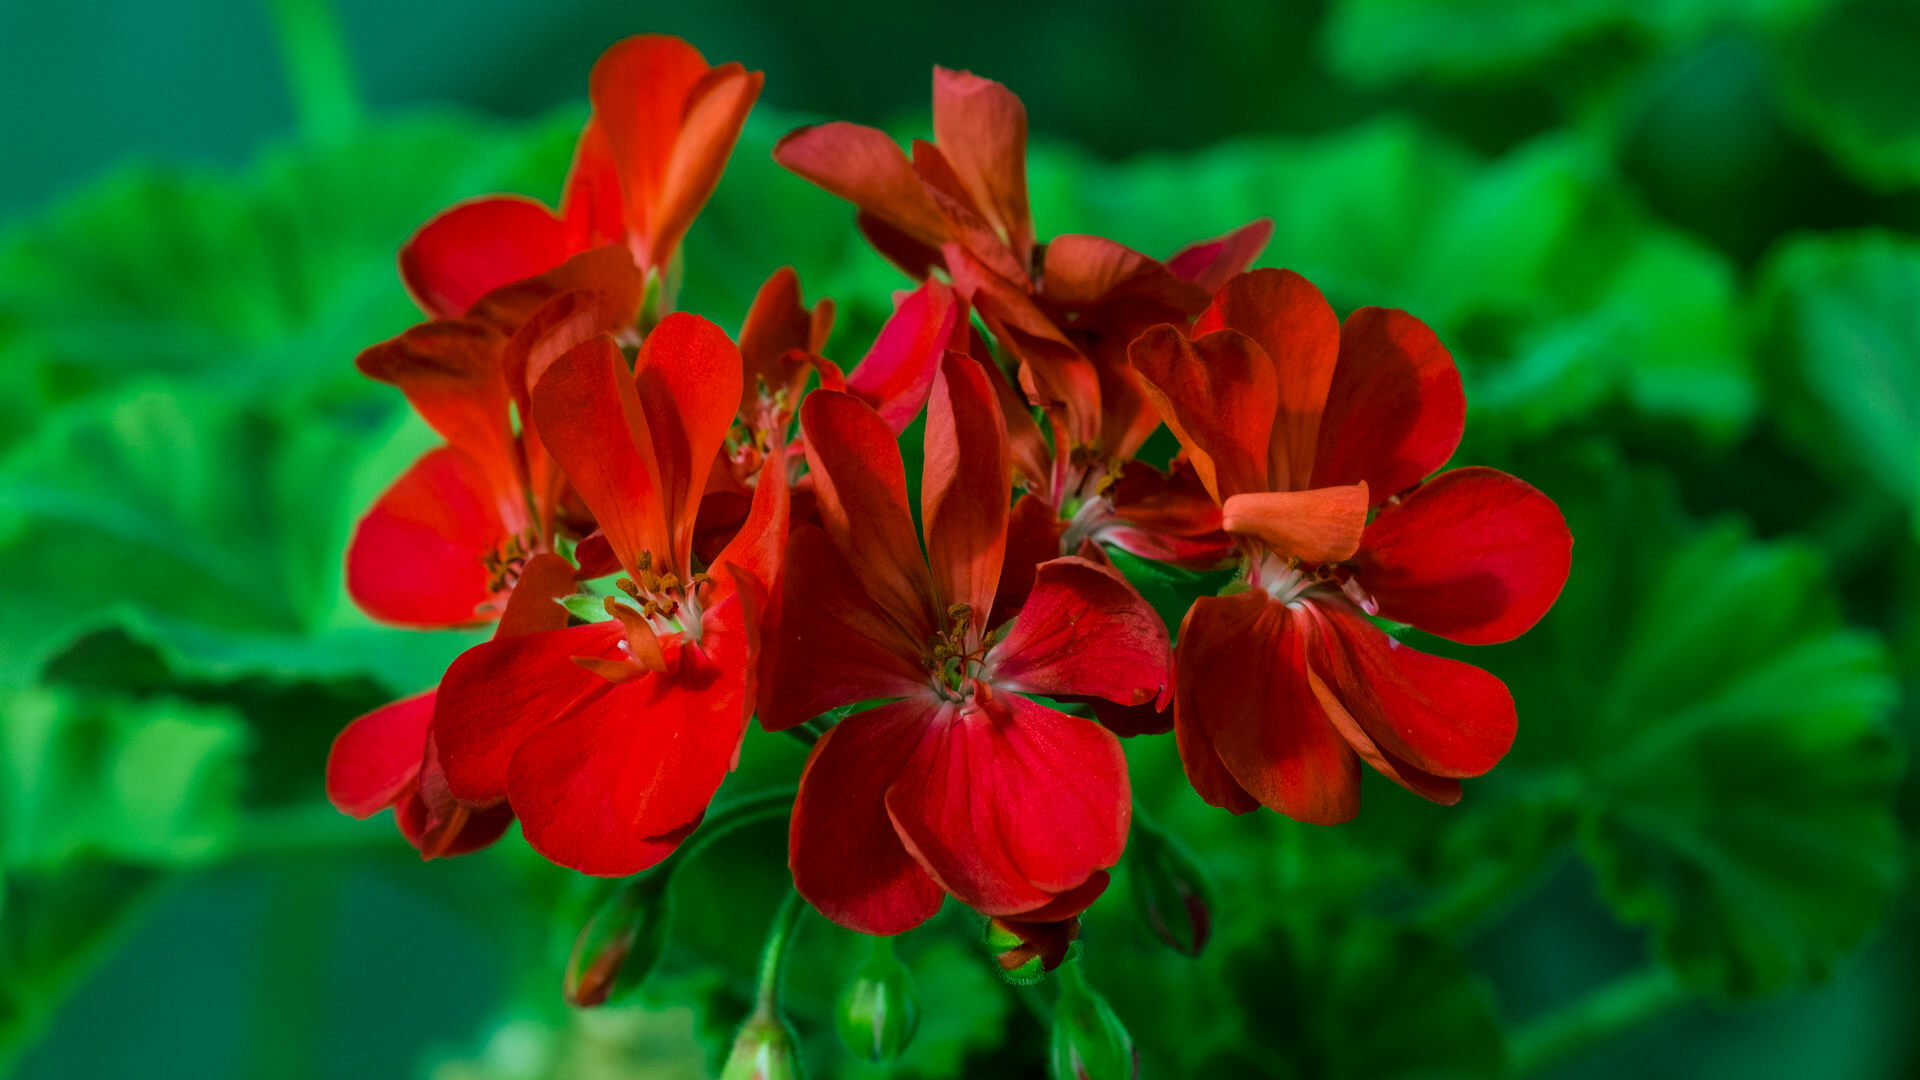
top-left (760, 525), bottom-right (929, 732)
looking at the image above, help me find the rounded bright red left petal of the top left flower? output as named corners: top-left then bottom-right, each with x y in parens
top-left (399, 194), bottom-right (570, 319)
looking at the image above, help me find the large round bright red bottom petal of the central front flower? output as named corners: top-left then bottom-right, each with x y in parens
top-left (887, 694), bottom-right (1133, 915)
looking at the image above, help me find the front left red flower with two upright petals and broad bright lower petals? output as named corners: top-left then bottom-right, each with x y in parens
top-left (432, 315), bottom-right (787, 874)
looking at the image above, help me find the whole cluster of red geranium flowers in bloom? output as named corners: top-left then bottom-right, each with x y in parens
top-left (328, 37), bottom-right (1572, 1060)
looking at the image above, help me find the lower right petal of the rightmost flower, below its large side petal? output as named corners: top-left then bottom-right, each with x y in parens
top-left (1309, 600), bottom-right (1517, 776)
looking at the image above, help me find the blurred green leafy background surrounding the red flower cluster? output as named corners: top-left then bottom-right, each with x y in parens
top-left (0, 0), bottom-right (1920, 1080)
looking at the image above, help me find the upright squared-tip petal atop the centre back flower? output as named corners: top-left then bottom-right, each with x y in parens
top-left (933, 67), bottom-right (1033, 265)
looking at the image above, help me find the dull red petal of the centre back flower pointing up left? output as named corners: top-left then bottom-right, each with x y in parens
top-left (774, 123), bottom-right (947, 248)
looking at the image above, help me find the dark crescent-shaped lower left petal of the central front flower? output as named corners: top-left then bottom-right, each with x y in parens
top-left (787, 698), bottom-right (945, 934)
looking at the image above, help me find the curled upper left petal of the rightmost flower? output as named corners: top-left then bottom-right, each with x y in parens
top-left (1127, 325), bottom-right (1279, 502)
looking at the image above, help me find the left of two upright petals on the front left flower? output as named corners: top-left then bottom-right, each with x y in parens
top-left (534, 334), bottom-right (668, 575)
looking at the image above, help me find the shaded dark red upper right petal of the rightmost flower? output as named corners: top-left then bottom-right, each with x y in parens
top-left (1311, 307), bottom-right (1467, 503)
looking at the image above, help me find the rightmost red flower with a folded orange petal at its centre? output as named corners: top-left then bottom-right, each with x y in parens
top-left (1131, 271), bottom-right (1572, 824)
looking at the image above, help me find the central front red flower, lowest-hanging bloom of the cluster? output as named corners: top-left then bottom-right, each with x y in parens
top-left (760, 354), bottom-right (1167, 934)
